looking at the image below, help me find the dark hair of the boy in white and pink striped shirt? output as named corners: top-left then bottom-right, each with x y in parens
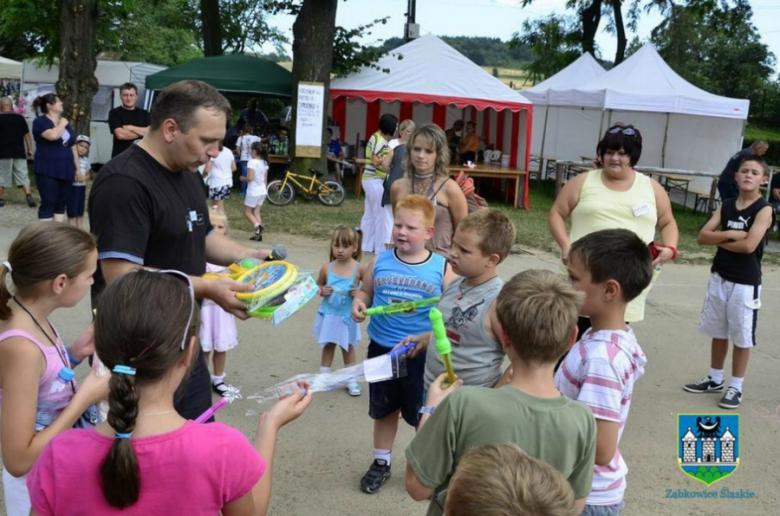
top-left (569, 229), bottom-right (653, 302)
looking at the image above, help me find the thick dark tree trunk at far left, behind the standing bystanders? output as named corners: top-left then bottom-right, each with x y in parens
top-left (56, 0), bottom-right (98, 134)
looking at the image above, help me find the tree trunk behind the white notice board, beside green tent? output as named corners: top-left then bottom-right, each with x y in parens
top-left (290, 0), bottom-right (338, 173)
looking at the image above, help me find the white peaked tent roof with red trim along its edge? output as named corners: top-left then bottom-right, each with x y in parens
top-left (330, 34), bottom-right (531, 111)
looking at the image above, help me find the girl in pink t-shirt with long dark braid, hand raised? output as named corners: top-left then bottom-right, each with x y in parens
top-left (28, 269), bottom-right (311, 515)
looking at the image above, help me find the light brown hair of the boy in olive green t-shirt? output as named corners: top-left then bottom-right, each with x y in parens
top-left (496, 269), bottom-right (585, 365)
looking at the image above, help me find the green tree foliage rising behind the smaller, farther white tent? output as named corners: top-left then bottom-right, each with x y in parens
top-left (509, 14), bottom-right (581, 83)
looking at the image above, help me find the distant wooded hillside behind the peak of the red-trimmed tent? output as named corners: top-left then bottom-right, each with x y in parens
top-left (381, 36), bottom-right (533, 69)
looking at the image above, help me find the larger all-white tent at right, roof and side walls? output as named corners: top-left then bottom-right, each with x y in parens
top-left (537, 44), bottom-right (749, 189)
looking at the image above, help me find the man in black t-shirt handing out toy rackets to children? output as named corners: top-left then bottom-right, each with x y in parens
top-left (89, 81), bottom-right (269, 419)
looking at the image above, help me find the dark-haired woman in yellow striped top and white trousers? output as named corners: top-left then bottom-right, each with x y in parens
top-left (360, 113), bottom-right (398, 254)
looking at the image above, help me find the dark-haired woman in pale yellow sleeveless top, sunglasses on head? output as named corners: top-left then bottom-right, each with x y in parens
top-left (547, 124), bottom-right (678, 324)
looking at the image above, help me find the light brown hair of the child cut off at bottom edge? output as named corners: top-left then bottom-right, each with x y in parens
top-left (444, 444), bottom-right (578, 516)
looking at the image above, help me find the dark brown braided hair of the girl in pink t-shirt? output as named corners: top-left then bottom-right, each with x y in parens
top-left (95, 269), bottom-right (200, 509)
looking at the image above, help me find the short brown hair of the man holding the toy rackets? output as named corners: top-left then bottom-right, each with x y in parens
top-left (151, 80), bottom-right (230, 133)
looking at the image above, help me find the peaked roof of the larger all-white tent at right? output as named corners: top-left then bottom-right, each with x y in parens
top-left (548, 43), bottom-right (750, 120)
